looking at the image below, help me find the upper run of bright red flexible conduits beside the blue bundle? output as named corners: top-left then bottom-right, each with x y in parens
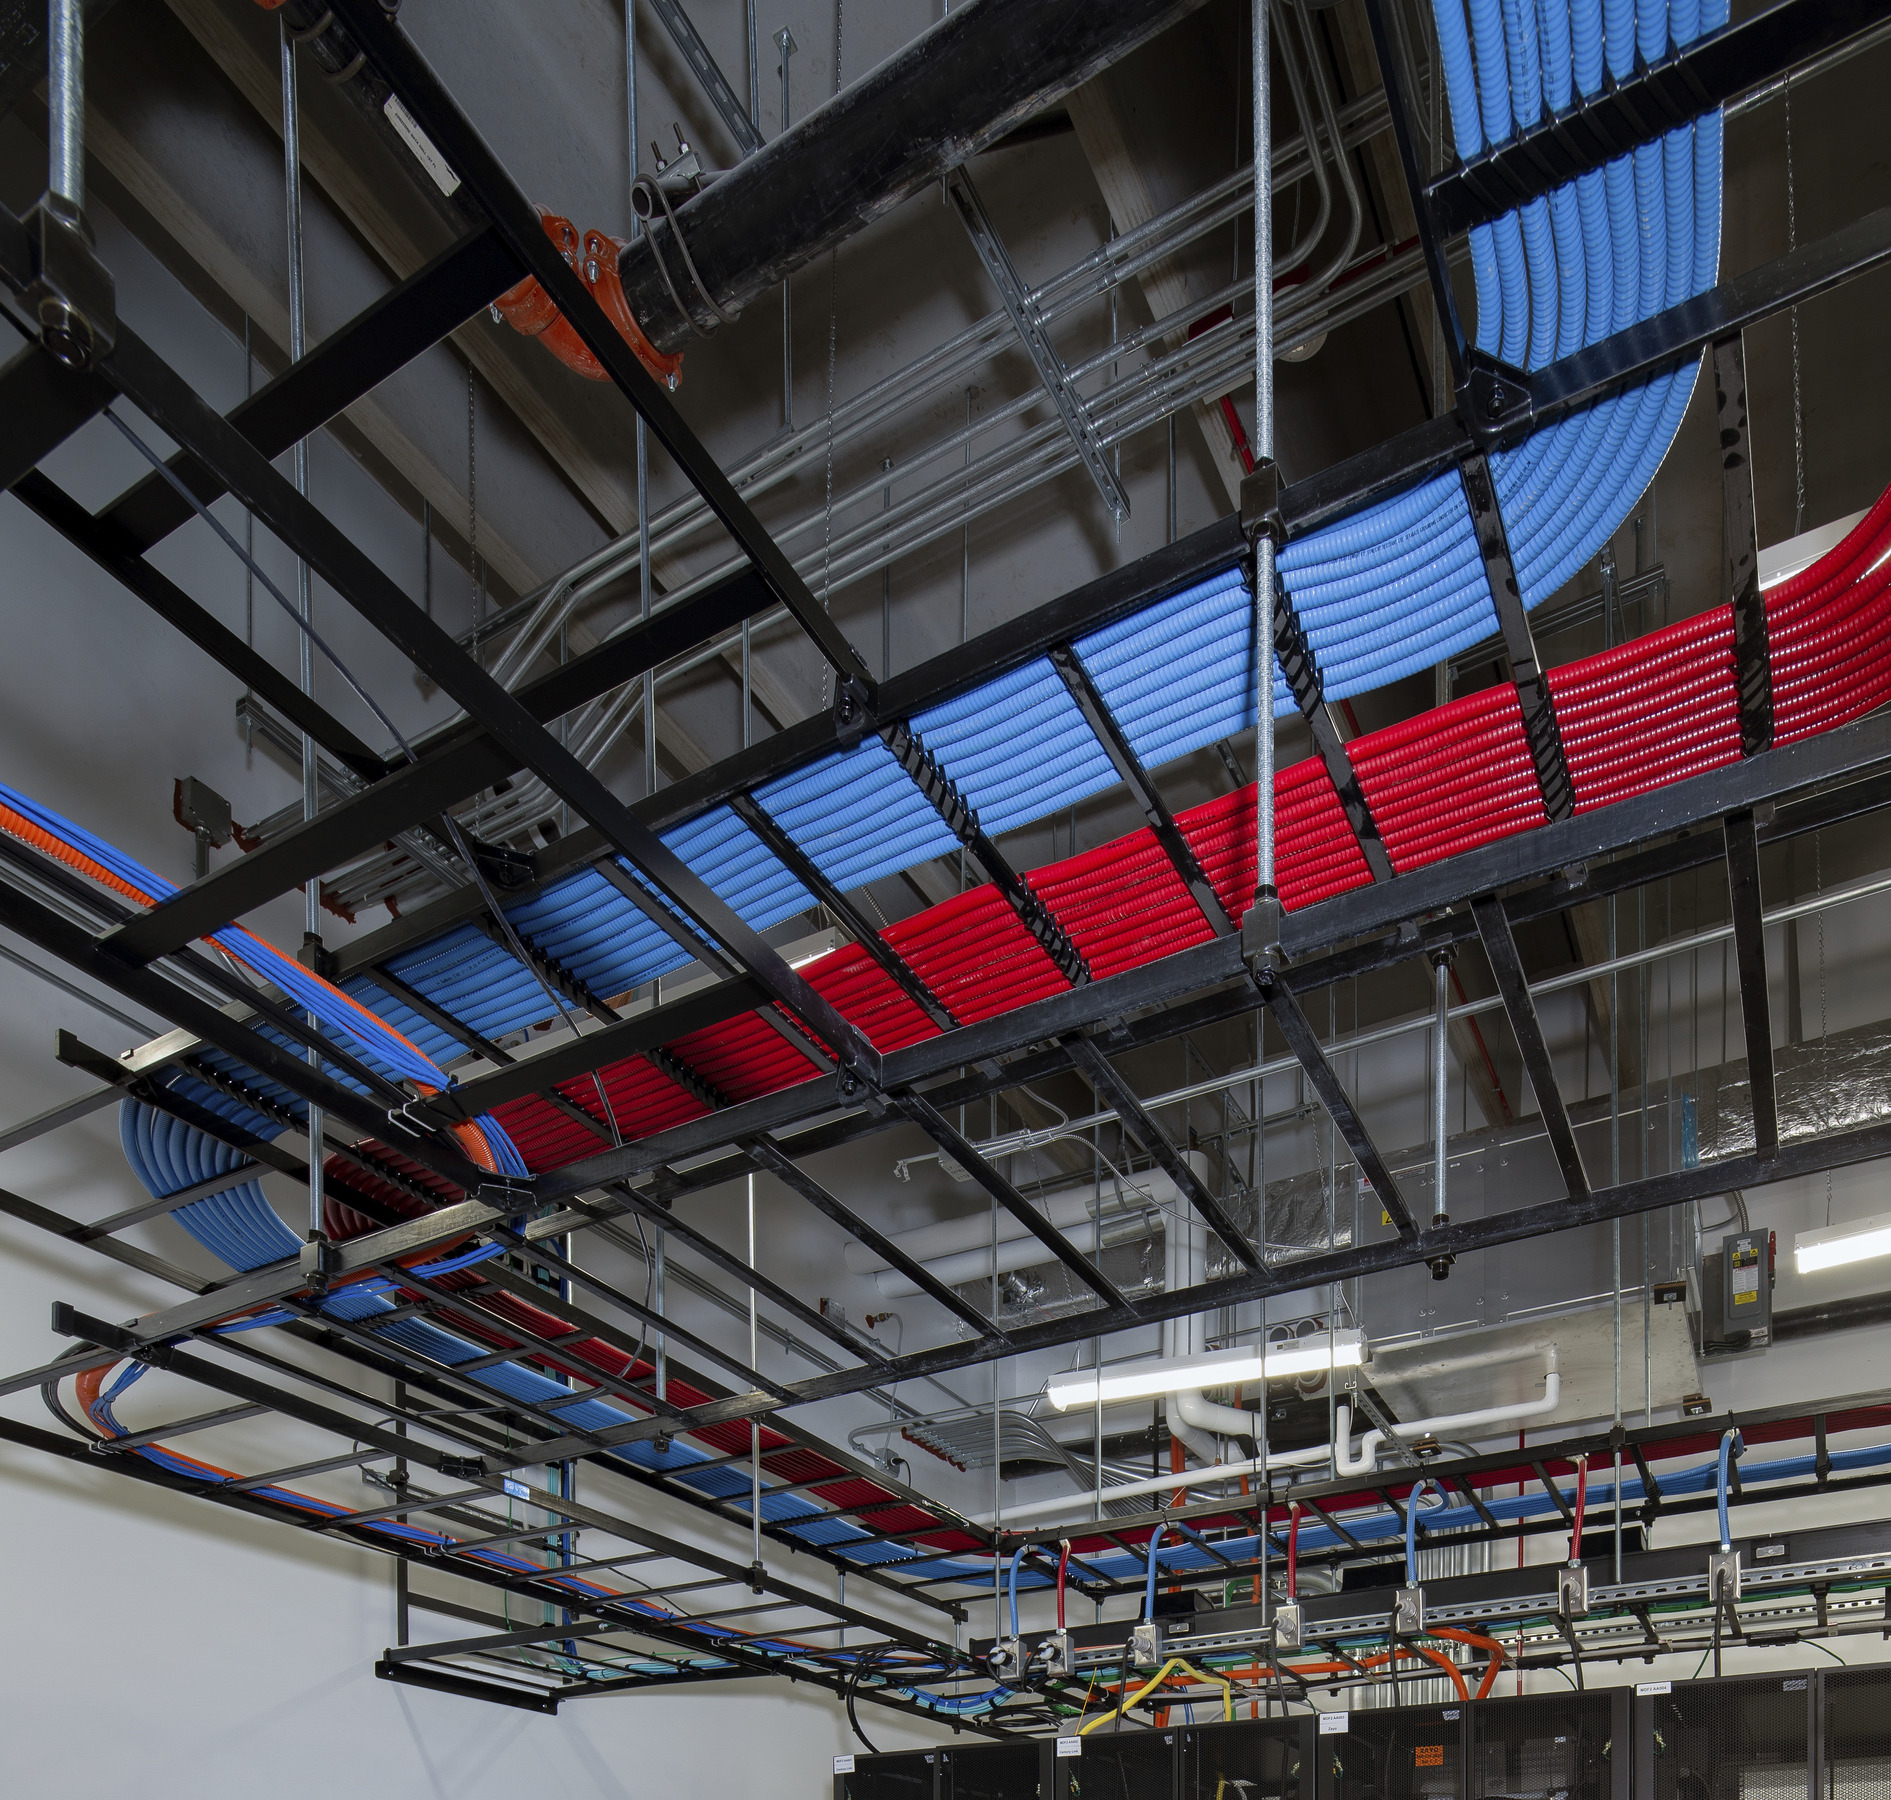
top-left (497, 490), bottom-right (1891, 1170)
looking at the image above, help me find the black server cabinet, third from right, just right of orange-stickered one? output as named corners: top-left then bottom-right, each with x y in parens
top-left (1464, 1688), bottom-right (1633, 1800)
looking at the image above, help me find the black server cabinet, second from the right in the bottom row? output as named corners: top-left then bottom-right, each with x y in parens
top-left (1636, 1671), bottom-right (1817, 1800)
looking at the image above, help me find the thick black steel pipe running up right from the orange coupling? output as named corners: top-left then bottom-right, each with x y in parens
top-left (618, 0), bottom-right (1201, 352)
